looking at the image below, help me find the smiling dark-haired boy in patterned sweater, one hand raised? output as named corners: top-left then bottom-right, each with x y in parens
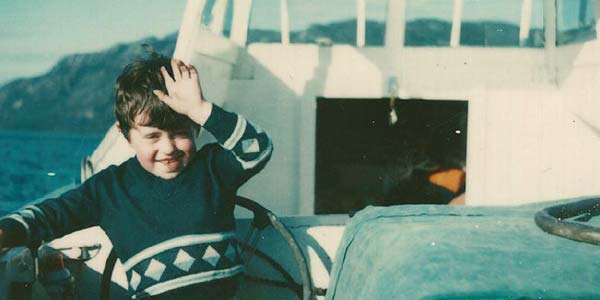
top-left (0, 57), bottom-right (273, 300)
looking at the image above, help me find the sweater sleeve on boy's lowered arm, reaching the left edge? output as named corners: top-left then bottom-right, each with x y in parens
top-left (0, 178), bottom-right (100, 247)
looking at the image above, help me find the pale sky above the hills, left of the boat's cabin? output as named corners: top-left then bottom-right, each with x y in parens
top-left (0, 0), bottom-right (186, 84)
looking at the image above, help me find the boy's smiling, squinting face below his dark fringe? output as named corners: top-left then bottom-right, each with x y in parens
top-left (129, 118), bottom-right (195, 179)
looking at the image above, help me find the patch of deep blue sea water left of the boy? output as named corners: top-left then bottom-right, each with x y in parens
top-left (0, 130), bottom-right (101, 216)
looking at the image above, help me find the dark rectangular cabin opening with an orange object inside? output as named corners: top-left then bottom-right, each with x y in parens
top-left (315, 98), bottom-right (468, 214)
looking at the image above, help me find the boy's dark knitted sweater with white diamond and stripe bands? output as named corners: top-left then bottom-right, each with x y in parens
top-left (0, 105), bottom-right (273, 299)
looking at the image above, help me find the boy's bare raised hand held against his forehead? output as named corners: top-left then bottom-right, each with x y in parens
top-left (152, 59), bottom-right (212, 125)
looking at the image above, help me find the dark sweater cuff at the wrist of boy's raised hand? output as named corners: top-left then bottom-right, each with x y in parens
top-left (203, 103), bottom-right (245, 148)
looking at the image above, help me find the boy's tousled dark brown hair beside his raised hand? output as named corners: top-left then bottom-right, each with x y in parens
top-left (115, 54), bottom-right (191, 139)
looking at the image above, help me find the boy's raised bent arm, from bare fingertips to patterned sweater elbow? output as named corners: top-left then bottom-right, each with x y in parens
top-left (154, 60), bottom-right (273, 188)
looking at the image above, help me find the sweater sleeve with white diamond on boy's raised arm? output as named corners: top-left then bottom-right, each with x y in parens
top-left (203, 104), bottom-right (273, 189)
